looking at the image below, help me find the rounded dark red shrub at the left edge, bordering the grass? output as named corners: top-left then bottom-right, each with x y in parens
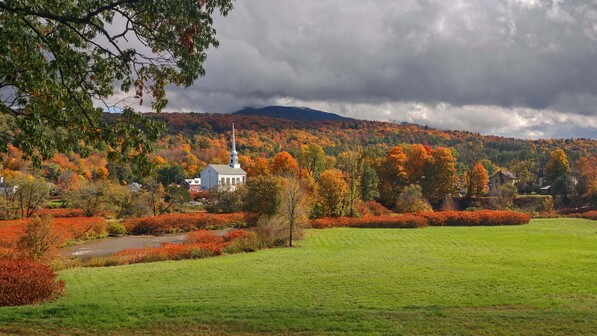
top-left (0, 259), bottom-right (64, 306)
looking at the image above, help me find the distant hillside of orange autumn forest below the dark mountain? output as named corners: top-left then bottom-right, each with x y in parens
top-left (146, 113), bottom-right (597, 167)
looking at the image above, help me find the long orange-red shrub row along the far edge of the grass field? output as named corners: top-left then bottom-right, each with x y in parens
top-left (311, 210), bottom-right (531, 229)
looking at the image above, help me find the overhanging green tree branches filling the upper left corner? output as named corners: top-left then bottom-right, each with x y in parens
top-left (0, 0), bottom-right (232, 163)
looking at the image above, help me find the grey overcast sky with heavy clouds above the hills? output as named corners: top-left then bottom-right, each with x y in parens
top-left (154, 0), bottom-right (597, 138)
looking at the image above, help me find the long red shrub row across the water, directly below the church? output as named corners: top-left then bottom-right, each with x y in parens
top-left (124, 213), bottom-right (256, 235)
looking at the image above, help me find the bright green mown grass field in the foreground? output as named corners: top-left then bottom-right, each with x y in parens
top-left (0, 219), bottom-right (597, 335)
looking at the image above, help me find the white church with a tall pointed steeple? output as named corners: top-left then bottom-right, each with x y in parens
top-left (201, 123), bottom-right (247, 191)
